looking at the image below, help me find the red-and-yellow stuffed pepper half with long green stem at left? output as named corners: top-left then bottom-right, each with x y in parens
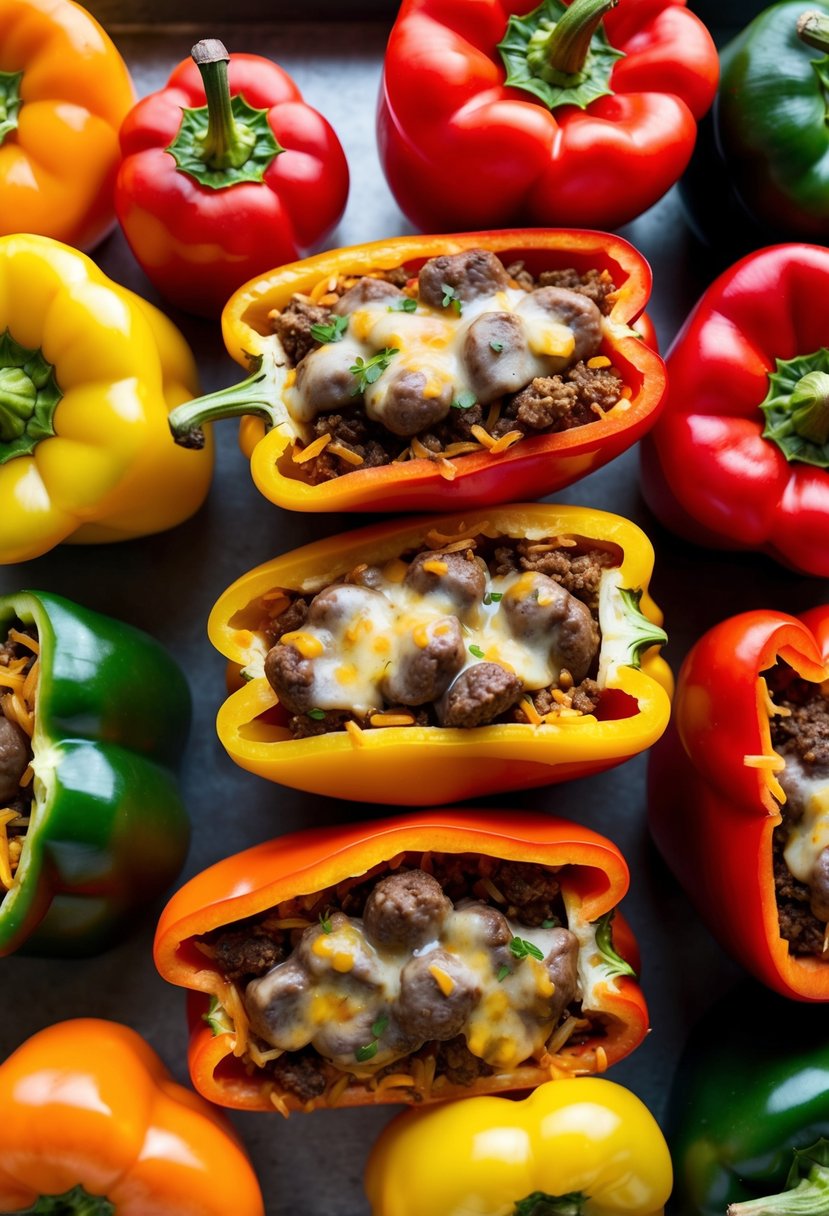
top-left (170, 229), bottom-right (665, 511)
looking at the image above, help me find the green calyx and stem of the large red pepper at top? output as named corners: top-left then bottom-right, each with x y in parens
top-left (497, 0), bottom-right (625, 109)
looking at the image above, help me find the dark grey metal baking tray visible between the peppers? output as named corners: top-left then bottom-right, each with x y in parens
top-left (0, 11), bottom-right (829, 1216)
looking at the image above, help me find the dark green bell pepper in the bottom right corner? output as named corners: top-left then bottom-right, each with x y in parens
top-left (667, 983), bottom-right (829, 1216)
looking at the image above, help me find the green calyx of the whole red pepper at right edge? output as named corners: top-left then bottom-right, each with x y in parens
top-left (760, 347), bottom-right (829, 468)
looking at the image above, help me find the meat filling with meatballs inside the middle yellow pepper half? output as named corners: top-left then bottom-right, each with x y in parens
top-left (258, 535), bottom-right (617, 738)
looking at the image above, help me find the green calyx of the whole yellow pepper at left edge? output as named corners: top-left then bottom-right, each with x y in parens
top-left (0, 330), bottom-right (63, 465)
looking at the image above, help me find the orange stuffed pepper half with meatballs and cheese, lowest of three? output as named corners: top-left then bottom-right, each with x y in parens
top-left (156, 809), bottom-right (648, 1115)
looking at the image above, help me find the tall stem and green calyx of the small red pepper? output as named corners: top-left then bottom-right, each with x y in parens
top-left (165, 38), bottom-right (284, 190)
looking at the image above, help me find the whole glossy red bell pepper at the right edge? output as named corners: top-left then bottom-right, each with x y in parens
top-left (642, 244), bottom-right (829, 578)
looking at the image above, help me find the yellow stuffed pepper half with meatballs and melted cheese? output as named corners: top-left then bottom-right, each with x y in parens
top-left (208, 505), bottom-right (671, 805)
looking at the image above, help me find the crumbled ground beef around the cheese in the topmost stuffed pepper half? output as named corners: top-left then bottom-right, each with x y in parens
top-left (270, 250), bottom-right (624, 485)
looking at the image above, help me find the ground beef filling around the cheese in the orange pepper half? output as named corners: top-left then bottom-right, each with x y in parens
top-left (197, 852), bottom-right (590, 1103)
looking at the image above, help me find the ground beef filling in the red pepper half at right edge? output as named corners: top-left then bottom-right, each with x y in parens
top-left (766, 662), bottom-right (829, 961)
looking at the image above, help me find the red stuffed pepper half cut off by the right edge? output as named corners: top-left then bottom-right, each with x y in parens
top-left (649, 604), bottom-right (829, 1001)
